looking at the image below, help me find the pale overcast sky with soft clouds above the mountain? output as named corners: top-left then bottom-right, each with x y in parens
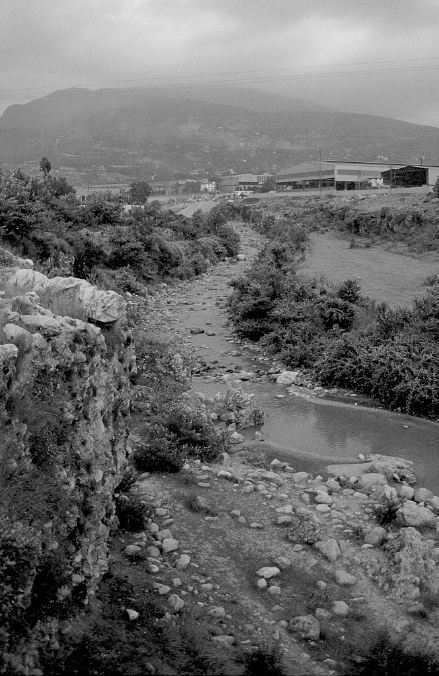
top-left (0, 0), bottom-right (439, 126)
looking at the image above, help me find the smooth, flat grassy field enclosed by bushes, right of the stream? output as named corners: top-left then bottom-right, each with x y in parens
top-left (301, 231), bottom-right (439, 307)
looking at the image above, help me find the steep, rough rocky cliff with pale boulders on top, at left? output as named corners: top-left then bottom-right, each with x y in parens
top-left (0, 252), bottom-right (135, 674)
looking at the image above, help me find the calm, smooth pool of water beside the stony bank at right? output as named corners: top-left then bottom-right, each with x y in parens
top-left (196, 374), bottom-right (439, 494)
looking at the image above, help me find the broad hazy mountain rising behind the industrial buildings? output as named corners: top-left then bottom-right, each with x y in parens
top-left (0, 86), bottom-right (439, 183)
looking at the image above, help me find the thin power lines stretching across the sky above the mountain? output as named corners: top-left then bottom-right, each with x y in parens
top-left (0, 56), bottom-right (439, 98)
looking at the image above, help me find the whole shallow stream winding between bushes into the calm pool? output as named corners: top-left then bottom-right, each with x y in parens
top-left (156, 226), bottom-right (439, 495)
